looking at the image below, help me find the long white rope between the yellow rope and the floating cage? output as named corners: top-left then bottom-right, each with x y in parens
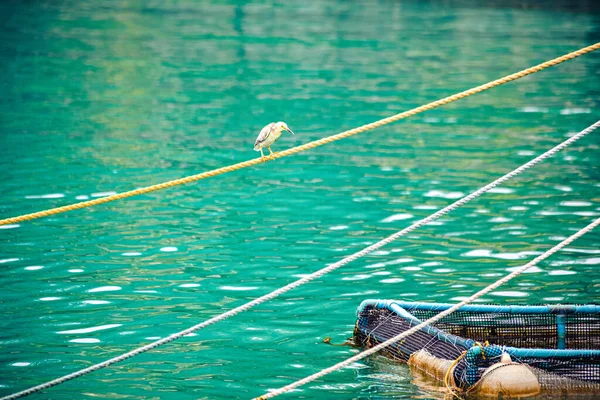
top-left (5, 121), bottom-right (600, 400)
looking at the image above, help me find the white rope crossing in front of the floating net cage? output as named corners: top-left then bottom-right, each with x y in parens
top-left (254, 218), bottom-right (600, 400)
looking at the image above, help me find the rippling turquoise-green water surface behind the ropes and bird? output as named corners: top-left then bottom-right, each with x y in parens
top-left (0, 1), bottom-right (600, 399)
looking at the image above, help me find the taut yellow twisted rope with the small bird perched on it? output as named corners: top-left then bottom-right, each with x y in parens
top-left (0, 42), bottom-right (600, 225)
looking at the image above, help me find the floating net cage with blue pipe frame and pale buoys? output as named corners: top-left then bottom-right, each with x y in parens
top-left (354, 300), bottom-right (600, 398)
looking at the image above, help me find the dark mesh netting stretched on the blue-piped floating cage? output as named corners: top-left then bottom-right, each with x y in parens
top-left (355, 306), bottom-right (600, 389)
